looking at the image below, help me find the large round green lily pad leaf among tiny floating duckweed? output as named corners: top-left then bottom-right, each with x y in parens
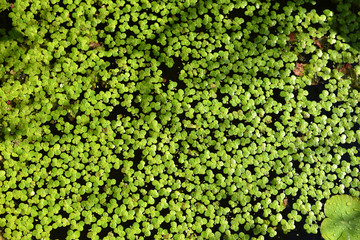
top-left (320, 195), bottom-right (360, 240)
